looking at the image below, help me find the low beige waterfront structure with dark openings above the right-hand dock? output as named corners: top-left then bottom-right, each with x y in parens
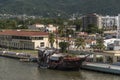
top-left (93, 51), bottom-right (120, 63)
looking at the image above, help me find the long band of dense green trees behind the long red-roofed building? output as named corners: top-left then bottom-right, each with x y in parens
top-left (0, 18), bottom-right (81, 30)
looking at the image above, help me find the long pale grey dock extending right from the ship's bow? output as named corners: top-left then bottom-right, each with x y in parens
top-left (81, 62), bottom-right (120, 75)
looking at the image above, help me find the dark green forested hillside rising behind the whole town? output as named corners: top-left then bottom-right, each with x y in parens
top-left (0, 0), bottom-right (120, 17)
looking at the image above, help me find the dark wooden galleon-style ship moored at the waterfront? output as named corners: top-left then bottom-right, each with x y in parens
top-left (38, 49), bottom-right (88, 70)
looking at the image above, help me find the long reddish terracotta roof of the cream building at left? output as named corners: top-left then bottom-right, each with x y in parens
top-left (0, 30), bottom-right (48, 36)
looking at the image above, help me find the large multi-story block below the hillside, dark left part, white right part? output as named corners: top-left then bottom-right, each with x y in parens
top-left (82, 13), bottom-right (120, 30)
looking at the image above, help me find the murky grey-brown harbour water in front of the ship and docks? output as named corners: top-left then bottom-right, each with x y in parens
top-left (0, 57), bottom-right (120, 80)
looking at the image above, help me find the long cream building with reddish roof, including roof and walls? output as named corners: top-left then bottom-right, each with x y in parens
top-left (0, 30), bottom-right (50, 49)
